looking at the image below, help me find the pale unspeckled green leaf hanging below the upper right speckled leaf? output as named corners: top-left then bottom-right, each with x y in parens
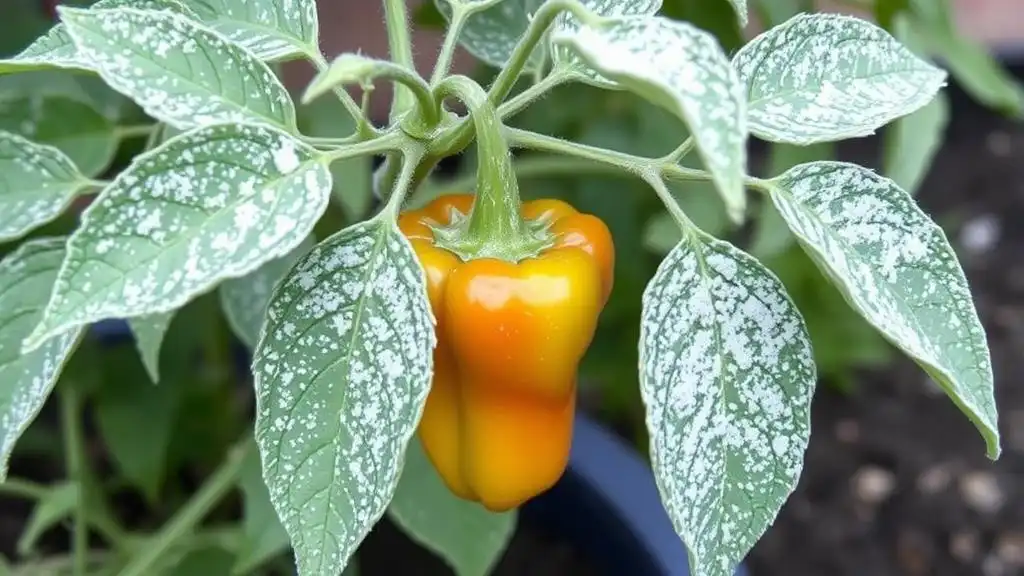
top-left (883, 92), bottom-right (949, 196)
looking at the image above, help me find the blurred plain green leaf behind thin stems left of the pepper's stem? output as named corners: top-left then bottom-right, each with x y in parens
top-left (298, 98), bottom-right (374, 221)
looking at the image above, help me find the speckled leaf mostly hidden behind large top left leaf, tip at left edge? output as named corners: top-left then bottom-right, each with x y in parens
top-left (0, 0), bottom-right (199, 74)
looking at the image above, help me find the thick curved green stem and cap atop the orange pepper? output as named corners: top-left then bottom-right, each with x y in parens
top-left (437, 76), bottom-right (547, 261)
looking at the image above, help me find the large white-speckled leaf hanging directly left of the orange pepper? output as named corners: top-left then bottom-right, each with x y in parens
top-left (253, 220), bottom-right (435, 576)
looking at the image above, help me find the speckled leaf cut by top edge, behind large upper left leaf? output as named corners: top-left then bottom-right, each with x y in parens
top-left (182, 0), bottom-right (319, 61)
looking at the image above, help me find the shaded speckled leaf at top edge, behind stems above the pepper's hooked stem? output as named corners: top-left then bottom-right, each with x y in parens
top-left (434, 0), bottom-right (545, 72)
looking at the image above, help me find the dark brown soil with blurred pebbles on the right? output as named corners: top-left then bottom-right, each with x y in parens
top-left (748, 65), bottom-right (1024, 576)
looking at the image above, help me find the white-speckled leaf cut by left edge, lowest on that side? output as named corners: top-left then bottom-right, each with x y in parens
top-left (0, 238), bottom-right (82, 482)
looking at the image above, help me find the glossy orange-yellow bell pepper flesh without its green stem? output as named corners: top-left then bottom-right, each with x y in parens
top-left (398, 195), bottom-right (614, 511)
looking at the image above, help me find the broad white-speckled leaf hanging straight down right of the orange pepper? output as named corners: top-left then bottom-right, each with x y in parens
top-left (640, 236), bottom-right (816, 576)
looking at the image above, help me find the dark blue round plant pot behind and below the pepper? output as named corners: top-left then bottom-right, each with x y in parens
top-left (91, 320), bottom-right (748, 576)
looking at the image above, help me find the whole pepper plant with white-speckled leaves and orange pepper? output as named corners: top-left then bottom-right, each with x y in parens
top-left (0, 0), bottom-right (999, 576)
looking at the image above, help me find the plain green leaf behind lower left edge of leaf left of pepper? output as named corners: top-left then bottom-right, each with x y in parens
top-left (231, 436), bottom-right (289, 574)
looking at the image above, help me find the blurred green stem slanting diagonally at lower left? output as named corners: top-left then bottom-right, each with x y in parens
top-left (120, 438), bottom-right (251, 576)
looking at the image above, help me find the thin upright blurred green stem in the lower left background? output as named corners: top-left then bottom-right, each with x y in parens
top-left (60, 382), bottom-right (89, 576)
